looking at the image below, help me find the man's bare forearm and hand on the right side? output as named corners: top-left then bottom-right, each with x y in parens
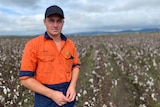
top-left (66, 68), bottom-right (79, 102)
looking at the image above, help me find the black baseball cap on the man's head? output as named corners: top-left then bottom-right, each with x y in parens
top-left (45, 5), bottom-right (64, 19)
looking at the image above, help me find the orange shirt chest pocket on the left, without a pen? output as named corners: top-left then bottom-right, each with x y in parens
top-left (37, 55), bottom-right (54, 73)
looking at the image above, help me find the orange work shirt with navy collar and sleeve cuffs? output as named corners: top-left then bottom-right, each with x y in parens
top-left (19, 32), bottom-right (80, 84)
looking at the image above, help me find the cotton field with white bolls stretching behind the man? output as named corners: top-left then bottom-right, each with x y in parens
top-left (0, 33), bottom-right (160, 107)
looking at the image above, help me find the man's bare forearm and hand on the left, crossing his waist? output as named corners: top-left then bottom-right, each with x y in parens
top-left (21, 77), bottom-right (69, 106)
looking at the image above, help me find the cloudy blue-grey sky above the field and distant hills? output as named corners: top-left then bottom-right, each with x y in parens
top-left (0, 0), bottom-right (160, 36)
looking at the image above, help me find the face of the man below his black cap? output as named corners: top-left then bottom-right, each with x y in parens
top-left (44, 14), bottom-right (64, 36)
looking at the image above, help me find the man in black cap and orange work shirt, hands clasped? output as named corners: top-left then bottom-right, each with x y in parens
top-left (19, 5), bottom-right (80, 107)
